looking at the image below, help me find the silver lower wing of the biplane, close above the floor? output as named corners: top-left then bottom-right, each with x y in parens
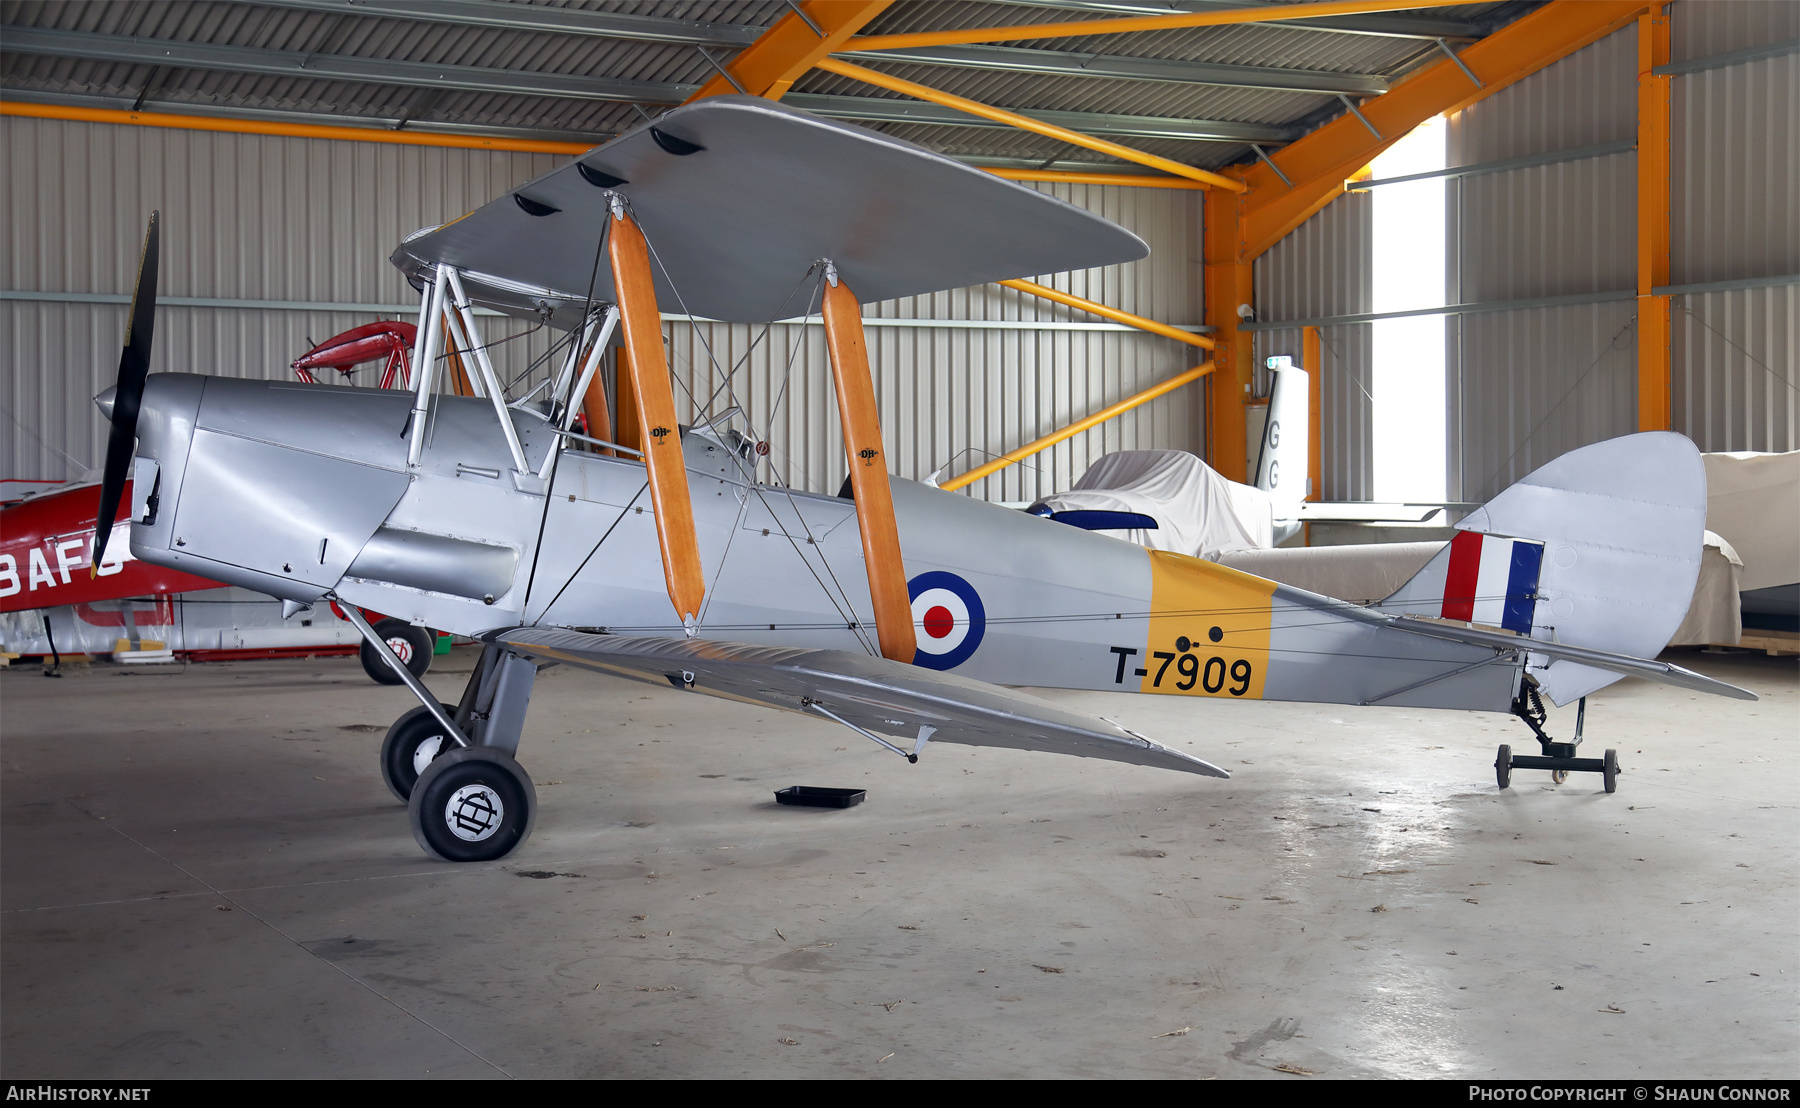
top-left (495, 628), bottom-right (1229, 777)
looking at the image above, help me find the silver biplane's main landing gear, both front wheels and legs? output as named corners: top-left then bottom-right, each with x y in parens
top-left (344, 604), bottom-right (538, 862)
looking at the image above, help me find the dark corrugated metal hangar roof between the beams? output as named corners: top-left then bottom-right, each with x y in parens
top-left (0, 0), bottom-right (1535, 167)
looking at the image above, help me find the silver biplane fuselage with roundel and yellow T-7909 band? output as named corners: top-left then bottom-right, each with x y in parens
top-left (131, 374), bottom-right (1519, 710)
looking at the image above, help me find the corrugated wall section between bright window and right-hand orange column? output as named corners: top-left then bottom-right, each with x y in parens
top-left (1445, 29), bottom-right (1638, 500)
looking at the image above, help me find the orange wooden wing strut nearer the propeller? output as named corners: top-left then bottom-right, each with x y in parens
top-left (607, 198), bottom-right (706, 633)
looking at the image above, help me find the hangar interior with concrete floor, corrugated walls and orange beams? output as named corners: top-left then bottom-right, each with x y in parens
top-left (0, 0), bottom-right (1800, 1079)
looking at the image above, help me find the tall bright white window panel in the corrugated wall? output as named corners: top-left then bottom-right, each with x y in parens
top-left (1370, 117), bottom-right (1449, 502)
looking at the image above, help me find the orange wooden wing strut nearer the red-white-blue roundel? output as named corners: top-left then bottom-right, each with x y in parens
top-left (824, 263), bottom-right (918, 662)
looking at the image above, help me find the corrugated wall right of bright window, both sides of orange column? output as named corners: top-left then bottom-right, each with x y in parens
top-left (1449, 0), bottom-right (1800, 500)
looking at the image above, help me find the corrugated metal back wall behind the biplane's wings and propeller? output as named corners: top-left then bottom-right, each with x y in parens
top-left (0, 117), bottom-right (1202, 500)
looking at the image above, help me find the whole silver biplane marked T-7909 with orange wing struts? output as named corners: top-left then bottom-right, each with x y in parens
top-left (94, 97), bottom-right (1750, 862)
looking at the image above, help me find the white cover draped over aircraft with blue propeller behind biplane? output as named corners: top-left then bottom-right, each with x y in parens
top-left (1039, 450), bottom-right (1274, 558)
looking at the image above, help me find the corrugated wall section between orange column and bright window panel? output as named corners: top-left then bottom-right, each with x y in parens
top-left (1255, 192), bottom-right (1375, 500)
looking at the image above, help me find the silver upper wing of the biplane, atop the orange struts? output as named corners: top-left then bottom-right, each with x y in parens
top-left (392, 97), bottom-right (1150, 327)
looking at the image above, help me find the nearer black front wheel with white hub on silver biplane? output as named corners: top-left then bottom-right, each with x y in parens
top-left (407, 746), bottom-right (538, 862)
